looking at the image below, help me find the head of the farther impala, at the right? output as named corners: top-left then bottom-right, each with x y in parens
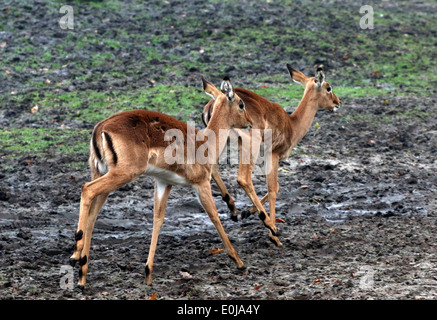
top-left (287, 64), bottom-right (340, 111)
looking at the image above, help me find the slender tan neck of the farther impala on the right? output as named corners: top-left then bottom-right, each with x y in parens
top-left (290, 88), bottom-right (318, 147)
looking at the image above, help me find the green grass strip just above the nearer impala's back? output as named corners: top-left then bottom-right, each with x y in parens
top-left (26, 84), bottom-right (209, 124)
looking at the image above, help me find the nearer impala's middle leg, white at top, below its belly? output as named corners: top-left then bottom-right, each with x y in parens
top-left (145, 180), bottom-right (172, 285)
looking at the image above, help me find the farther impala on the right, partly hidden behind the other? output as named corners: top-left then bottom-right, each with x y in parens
top-left (202, 64), bottom-right (340, 246)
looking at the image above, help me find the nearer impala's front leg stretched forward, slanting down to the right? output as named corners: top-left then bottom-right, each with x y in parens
top-left (196, 181), bottom-right (244, 269)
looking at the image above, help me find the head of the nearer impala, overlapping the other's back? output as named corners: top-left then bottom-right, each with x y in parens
top-left (202, 77), bottom-right (253, 129)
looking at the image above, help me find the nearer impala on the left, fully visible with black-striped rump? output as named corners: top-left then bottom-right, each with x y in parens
top-left (71, 77), bottom-right (252, 289)
